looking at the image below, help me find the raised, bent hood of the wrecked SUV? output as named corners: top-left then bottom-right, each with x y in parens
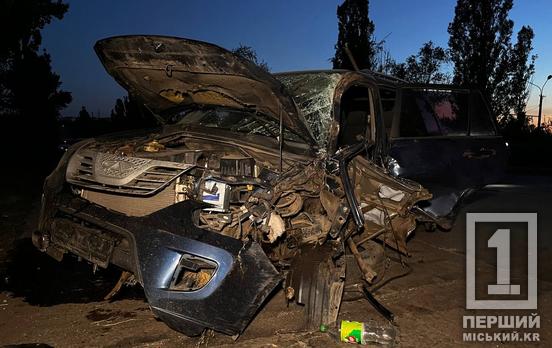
top-left (94, 36), bottom-right (314, 144)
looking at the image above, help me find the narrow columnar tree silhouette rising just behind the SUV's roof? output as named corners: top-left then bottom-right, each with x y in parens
top-left (332, 0), bottom-right (376, 70)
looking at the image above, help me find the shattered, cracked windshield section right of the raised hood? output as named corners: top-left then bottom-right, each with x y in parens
top-left (275, 72), bottom-right (341, 148)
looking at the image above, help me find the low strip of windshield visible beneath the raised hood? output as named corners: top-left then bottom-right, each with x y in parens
top-left (175, 108), bottom-right (303, 142)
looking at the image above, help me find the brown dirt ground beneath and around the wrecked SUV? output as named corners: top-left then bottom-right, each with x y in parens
top-left (0, 178), bottom-right (552, 347)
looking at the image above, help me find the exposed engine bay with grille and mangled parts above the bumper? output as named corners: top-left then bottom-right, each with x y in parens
top-left (67, 134), bottom-right (428, 260)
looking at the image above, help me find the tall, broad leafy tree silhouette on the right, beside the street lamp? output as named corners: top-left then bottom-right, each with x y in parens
top-left (448, 0), bottom-right (533, 122)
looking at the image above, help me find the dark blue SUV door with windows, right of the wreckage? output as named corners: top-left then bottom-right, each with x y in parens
top-left (389, 85), bottom-right (505, 216)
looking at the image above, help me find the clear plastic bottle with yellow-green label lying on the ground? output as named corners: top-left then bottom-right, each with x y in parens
top-left (320, 320), bottom-right (397, 345)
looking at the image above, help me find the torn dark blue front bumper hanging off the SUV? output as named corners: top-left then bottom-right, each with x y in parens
top-left (33, 189), bottom-right (282, 336)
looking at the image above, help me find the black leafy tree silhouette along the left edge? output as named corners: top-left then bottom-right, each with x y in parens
top-left (0, 0), bottom-right (71, 169)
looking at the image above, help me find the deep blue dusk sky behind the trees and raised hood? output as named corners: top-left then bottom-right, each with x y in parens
top-left (43, 0), bottom-right (552, 116)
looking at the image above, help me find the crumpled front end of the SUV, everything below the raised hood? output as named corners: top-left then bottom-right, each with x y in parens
top-left (34, 132), bottom-right (431, 335)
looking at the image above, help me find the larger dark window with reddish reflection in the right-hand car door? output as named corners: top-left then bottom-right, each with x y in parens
top-left (400, 89), bottom-right (469, 137)
